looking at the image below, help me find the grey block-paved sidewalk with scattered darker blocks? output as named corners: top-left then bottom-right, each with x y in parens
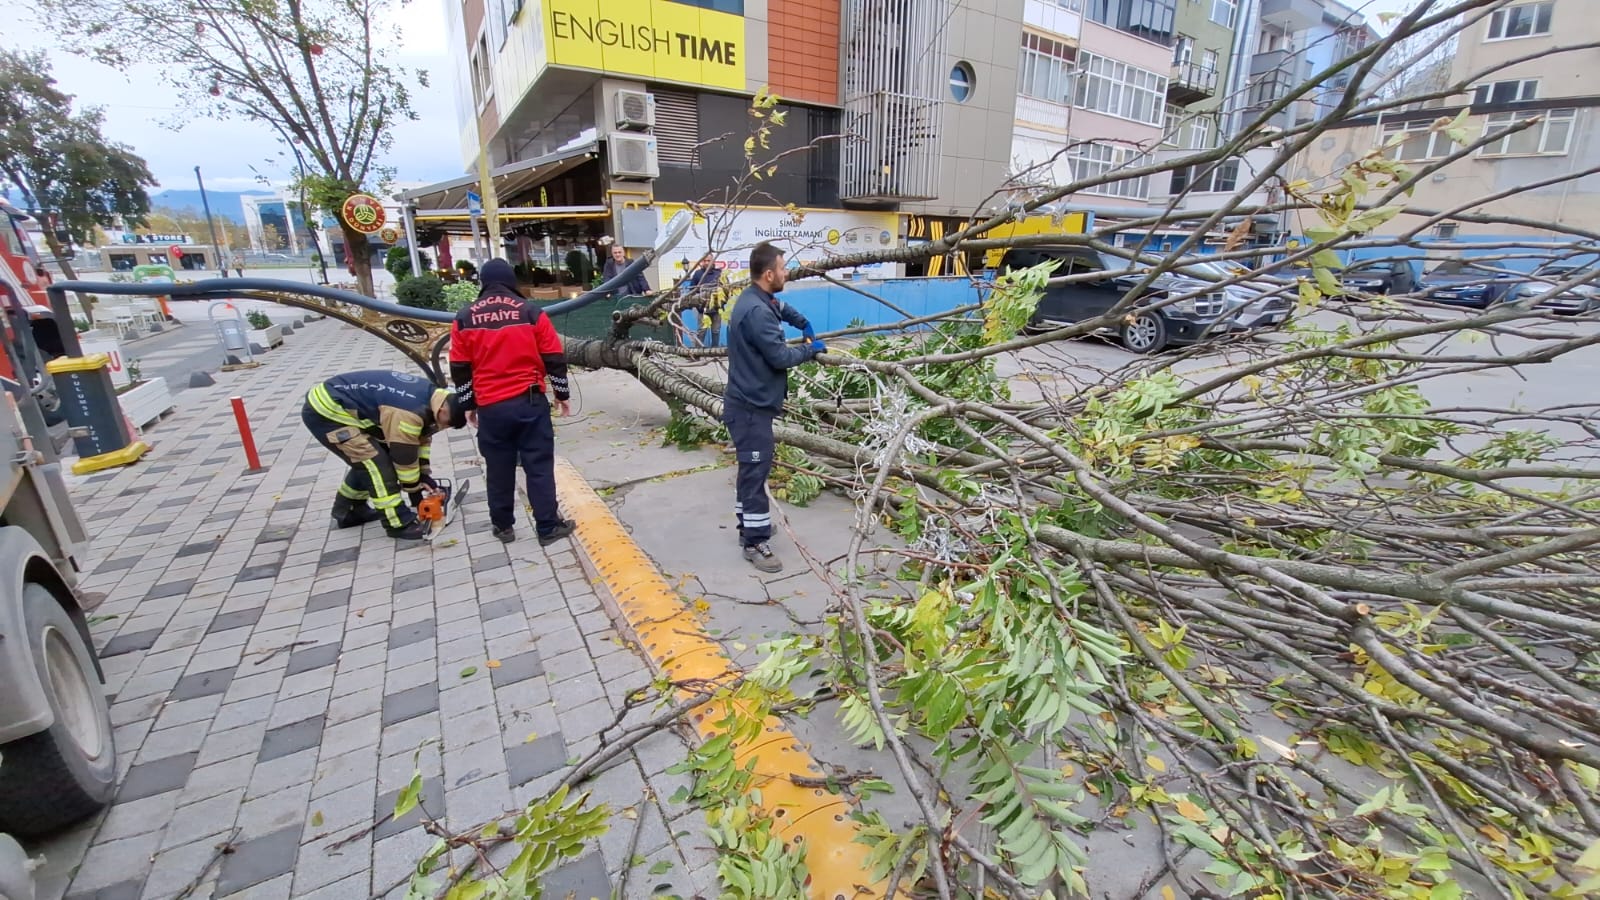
top-left (30, 320), bottom-right (717, 900)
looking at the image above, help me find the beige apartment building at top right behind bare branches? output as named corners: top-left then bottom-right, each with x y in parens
top-left (1294, 0), bottom-right (1600, 240)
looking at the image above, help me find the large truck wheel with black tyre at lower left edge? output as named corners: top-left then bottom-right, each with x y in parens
top-left (0, 583), bottom-right (117, 836)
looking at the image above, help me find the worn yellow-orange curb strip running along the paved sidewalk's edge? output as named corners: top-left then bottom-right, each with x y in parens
top-left (555, 458), bottom-right (885, 900)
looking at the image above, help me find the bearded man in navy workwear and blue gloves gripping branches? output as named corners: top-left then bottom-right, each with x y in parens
top-left (722, 243), bottom-right (827, 572)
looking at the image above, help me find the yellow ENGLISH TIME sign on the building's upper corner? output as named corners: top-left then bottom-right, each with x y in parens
top-left (544, 0), bottom-right (747, 91)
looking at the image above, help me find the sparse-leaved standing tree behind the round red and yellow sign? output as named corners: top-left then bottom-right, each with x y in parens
top-left (38, 0), bottom-right (427, 295)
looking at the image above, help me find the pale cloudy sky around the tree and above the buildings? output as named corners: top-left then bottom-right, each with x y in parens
top-left (0, 0), bottom-right (1413, 191)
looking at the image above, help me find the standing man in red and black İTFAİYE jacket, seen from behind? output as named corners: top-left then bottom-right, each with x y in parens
top-left (450, 259), bottom-right (573, 546)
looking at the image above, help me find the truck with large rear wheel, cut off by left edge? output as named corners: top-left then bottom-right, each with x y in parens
top-left (0, 200), bottom-right (117, 900)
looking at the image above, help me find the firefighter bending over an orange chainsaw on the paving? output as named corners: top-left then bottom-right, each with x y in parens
top-left (301, 370), bottom-right (467, 541)
